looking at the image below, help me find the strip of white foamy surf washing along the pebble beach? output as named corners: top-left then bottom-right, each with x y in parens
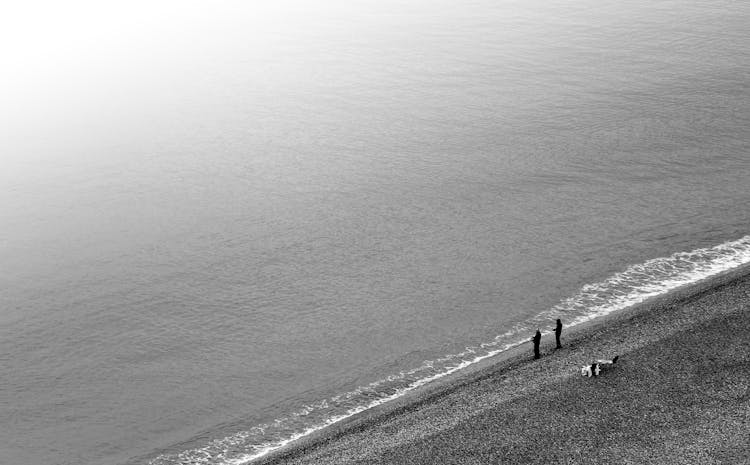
top-left (149, 235), bottom-right (750, 465)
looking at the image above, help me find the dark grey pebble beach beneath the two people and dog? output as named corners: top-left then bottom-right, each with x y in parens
top-left (254, 266), bottom-right (750, 464)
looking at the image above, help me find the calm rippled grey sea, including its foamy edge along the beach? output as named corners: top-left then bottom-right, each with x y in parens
top-left (0, 0), bottom-right (750, 465)
